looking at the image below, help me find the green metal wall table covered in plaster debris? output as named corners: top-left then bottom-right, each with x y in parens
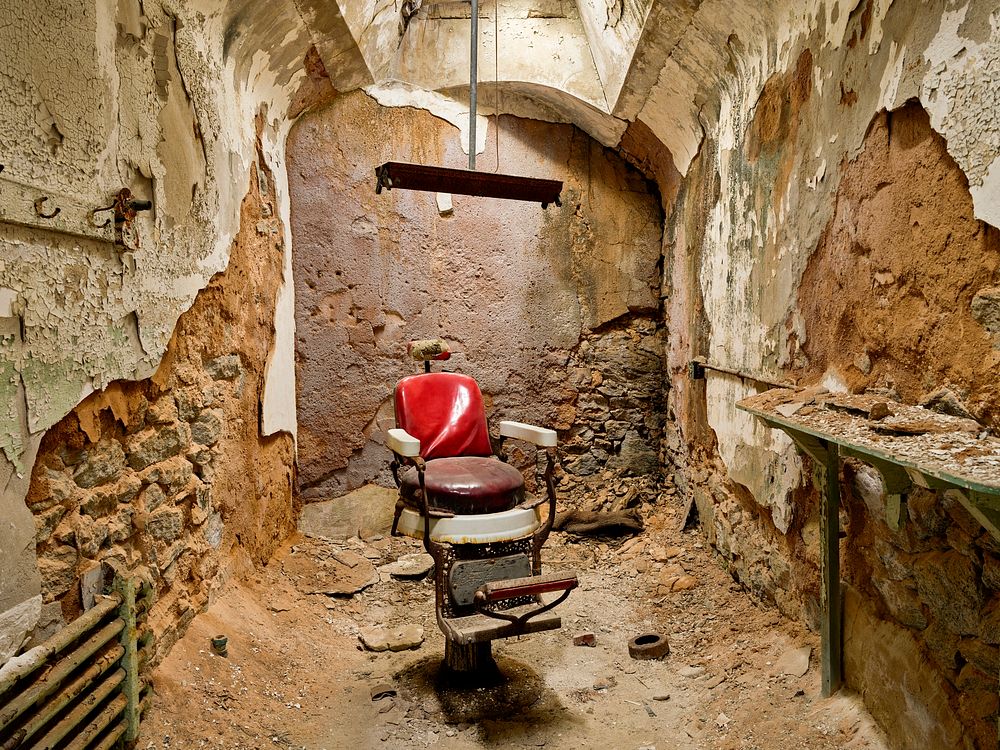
top-left (736, 389), bottom-right (1000, 696)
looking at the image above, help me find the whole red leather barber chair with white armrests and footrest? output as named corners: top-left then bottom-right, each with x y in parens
top-left (386, 339), bottom-right (577, 673)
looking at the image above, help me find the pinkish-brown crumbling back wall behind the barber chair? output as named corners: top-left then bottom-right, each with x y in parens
top-left (288, 92), bottom-right (664, 502)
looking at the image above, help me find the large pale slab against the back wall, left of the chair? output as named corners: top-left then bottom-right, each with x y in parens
top-left (299, 484), bottom-right (397, 539)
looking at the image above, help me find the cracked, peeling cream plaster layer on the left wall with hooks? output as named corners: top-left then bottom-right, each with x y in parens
top-left (0, 0), bottom-right (322, 661)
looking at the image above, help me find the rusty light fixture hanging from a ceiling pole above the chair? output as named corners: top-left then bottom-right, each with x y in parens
top-left (375, 0), bottom-right (562, 208)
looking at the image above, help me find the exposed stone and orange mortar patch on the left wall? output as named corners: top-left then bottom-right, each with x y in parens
top-left (21, 157), bottom-right (294, 655)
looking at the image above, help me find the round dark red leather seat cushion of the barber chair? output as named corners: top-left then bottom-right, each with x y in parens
top-left (399, 456), bottom-right (524, 514)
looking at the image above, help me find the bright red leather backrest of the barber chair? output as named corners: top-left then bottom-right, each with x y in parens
top-left (396, 372), bottom-right (493, 459)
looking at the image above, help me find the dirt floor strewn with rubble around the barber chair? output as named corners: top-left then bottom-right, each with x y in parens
top-left (138, 498), bottom-right (887, 750)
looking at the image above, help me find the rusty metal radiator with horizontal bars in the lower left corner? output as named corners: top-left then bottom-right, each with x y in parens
top-left (0, 577), bottom-right (152, 750)
